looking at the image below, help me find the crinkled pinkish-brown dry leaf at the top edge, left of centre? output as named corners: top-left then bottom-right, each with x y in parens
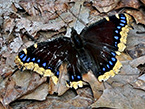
top-left (14, 0), bottom-right (68, 23)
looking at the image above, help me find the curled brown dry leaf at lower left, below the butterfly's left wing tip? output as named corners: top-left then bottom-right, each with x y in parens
top-left (1, 71), bottom-right (46, 106)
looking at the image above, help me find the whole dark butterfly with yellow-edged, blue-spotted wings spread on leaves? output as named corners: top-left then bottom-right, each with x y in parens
top-left (15, 14), bottom-right (133, 89)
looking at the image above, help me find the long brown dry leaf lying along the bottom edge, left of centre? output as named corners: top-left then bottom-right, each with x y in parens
top-left (16, 92), bottom-right (92, 109)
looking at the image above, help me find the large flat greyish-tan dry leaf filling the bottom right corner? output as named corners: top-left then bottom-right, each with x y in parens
top-left (91, 84), bottom-right (145, 109)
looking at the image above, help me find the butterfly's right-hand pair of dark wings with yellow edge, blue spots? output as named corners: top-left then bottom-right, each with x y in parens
top-left (81, 14), bottom-right (132, 81)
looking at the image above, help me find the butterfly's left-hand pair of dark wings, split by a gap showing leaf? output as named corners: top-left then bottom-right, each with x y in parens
top-left (15, 37), bottom-right (82, 87)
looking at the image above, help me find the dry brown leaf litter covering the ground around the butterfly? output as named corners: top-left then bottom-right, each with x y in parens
top-left (0, 0), bottom-right (145, 109)
